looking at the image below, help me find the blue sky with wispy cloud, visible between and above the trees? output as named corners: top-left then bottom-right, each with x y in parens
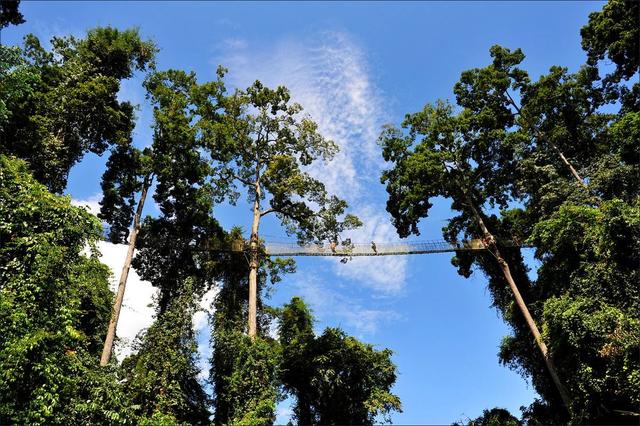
top-left (2, 1), bottom-right (602, 424)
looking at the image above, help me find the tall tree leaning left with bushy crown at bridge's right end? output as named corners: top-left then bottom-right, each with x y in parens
top-left (381, 98), bottom-right (570, 408)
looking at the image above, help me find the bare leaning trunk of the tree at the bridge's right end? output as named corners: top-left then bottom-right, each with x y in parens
top-left (466, 196), bottom-right (571, 411)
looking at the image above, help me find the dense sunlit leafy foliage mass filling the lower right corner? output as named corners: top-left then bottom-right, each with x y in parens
top-left (520, 199), bottom-right (640, 422)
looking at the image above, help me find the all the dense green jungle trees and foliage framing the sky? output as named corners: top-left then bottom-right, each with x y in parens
top-left (0, 0), bottom-right (640, 425)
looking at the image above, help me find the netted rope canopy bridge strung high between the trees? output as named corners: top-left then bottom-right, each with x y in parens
top-left (204, 239), bottom-right (528, 257)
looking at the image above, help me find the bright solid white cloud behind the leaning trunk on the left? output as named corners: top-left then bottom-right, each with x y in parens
top-left (98, 241), bottom-right (158, 361)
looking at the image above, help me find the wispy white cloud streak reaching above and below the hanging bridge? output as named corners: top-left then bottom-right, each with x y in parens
top-left (215, 32), bottom-right (407, 294)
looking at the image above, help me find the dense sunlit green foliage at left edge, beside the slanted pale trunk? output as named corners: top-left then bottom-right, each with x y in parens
top-left (0, 156), bottom-right (126, 424)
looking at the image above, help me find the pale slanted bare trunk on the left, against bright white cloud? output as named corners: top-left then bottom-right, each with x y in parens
top-left (100, 176), bottom-right (152, 366)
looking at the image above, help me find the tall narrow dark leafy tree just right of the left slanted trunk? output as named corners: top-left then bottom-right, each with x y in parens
top-left (117, 71), bottom-right (230, 423)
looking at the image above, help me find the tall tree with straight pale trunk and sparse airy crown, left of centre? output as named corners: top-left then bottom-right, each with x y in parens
top-left (211, 81), bottom-right (360, 338)
